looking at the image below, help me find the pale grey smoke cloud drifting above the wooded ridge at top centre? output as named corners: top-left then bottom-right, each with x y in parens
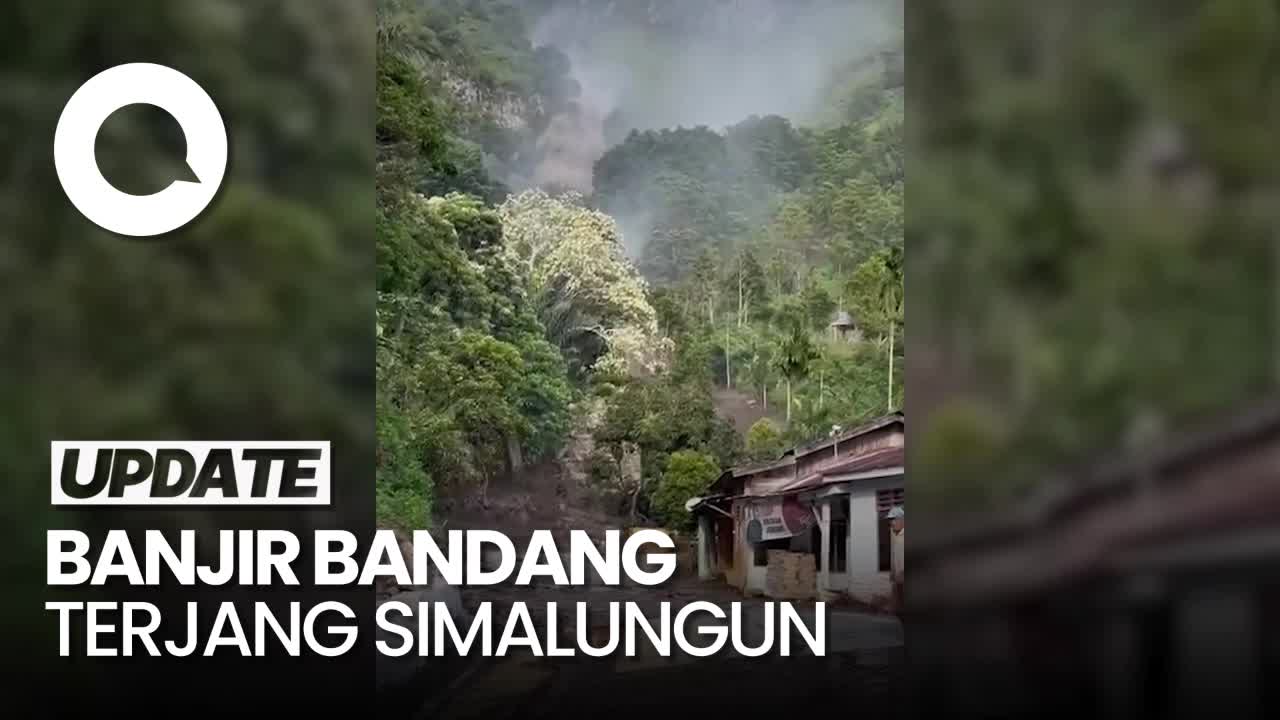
top-left (530, 0), bottom-right (901, 196)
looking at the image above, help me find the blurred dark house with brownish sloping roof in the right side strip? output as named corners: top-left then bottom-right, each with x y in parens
top-left (908, 398), bottom-right (1280, 717)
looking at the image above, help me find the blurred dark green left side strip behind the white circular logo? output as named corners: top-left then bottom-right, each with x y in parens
top-left (0, 0), bottom-right (374, 711)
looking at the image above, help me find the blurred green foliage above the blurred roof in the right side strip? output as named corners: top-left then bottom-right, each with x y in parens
top-left (906, 0), bottom-right (1280, 510)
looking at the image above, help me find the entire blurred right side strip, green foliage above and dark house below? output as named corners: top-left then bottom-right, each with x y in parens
top-left (906, 0), bottom-right (1280, 717)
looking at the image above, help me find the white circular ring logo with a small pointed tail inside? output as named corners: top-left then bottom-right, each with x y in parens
top-left (54, 63), bottom-right (227, 237)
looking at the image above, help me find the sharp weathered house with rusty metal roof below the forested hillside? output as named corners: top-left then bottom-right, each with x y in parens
top-left (690, 413), bottom-right (906, 603)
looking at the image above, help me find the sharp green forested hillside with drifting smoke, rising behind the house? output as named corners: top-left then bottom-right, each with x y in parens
top-left (378, 0), bottom-right (904, 527)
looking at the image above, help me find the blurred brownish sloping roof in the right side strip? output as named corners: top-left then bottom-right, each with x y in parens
top-left (913, 401), bottom-right (1280, 603)
